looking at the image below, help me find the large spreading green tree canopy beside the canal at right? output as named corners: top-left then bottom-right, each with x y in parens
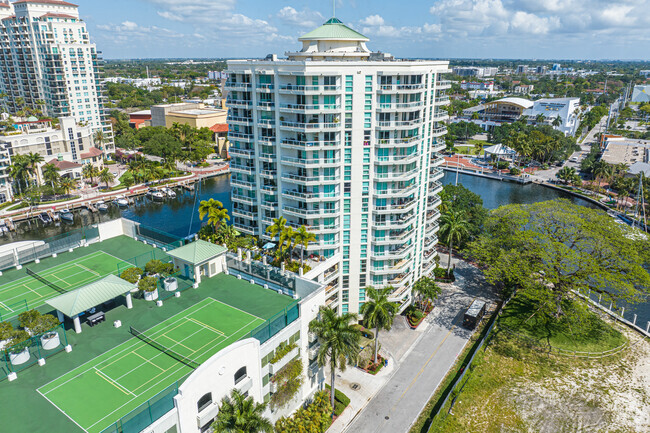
top-left (471, 199), bottom-right (650, 319)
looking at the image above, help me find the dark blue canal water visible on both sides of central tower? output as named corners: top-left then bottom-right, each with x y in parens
top-left (0, 172), bottom-right (650, 328)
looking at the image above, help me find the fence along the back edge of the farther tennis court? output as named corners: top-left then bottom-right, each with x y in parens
top-left (0, 225), bottom-right (100, 270)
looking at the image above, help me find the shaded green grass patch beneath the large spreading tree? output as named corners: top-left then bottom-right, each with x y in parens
top-left (500, 296), bottom-right (625, 352)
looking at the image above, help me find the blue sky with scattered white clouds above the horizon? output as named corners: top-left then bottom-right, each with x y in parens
top-left (76, 0), bottom-right (650, 60)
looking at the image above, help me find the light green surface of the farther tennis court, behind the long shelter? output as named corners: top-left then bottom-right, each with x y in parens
top-left (0, 251), bottom-right (124, 317)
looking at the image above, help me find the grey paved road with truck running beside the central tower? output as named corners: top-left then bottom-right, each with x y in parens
top-left (344, 260), bottom-right (492, 433)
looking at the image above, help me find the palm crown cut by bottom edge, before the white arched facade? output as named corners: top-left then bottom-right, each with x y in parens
top-left (212, 389), bottom-right (273, 433)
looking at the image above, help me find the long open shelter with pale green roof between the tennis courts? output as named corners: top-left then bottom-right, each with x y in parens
top-left (45, 275), bottom-right (134, 334)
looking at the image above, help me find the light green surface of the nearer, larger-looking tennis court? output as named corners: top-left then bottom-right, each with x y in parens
top-left (38, 298), bottom-right (264, 433)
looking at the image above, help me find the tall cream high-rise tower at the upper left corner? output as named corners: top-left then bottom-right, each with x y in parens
top-left (0, 0), bottom-right (113, 147)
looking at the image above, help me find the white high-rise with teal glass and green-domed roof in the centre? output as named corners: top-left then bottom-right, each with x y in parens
top-left (225, 18), bottom-right (450, 313)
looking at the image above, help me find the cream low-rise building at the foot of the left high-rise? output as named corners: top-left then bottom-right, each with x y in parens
top-left (0, 117), bottom-right (104, 203)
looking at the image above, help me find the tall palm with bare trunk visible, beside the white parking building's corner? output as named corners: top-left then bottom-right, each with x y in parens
top-left (309, 307), bottom-right (361, 407)
